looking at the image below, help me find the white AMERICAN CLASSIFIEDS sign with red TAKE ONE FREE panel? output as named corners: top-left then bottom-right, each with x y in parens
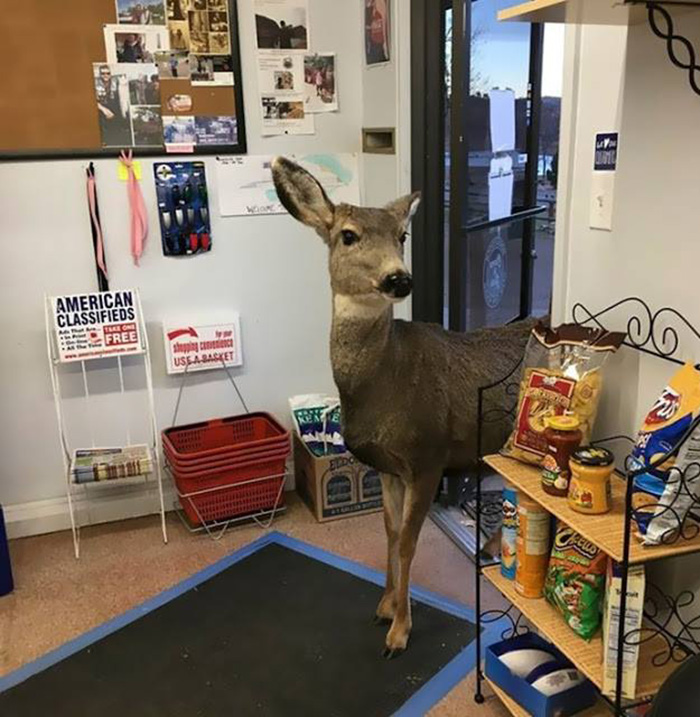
top-left (51, 290), bottom-right (144, 363)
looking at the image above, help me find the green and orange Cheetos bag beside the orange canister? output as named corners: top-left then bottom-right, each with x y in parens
top-left (544, 522), bottom-right (608, 640)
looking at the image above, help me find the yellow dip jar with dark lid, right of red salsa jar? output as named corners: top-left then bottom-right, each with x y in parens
top-left (569, 446), bottom-right (615, 515)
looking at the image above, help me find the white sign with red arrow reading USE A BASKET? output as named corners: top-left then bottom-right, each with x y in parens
top-left (163, 314), bottom-right (243, 374)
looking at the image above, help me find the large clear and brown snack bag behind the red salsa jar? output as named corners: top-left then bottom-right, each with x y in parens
top-left (501, 324), bottom-right (625, 465)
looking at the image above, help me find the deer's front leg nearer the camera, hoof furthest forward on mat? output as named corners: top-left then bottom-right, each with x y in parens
top-left (384, 476), bottom-right (440, 659)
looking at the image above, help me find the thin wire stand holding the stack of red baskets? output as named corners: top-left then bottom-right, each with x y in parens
top-left (163, 359), bottom-right (289, 541)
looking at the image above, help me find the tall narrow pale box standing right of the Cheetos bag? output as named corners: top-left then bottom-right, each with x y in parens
top-left (603, 560), bottom-right (644, 700)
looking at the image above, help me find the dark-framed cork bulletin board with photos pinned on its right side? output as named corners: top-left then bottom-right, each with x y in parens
top-left (0, 0), bottom-right (246, 160)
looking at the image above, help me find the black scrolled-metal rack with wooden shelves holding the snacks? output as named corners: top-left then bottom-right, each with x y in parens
top-left (474, 297), bottom-right (700, 717)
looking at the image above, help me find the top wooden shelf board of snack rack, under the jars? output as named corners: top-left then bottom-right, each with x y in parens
top-left (484, 455), bottom-right (700, 563)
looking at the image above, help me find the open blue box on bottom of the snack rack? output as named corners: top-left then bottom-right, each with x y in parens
top-left (485, 633), bottom-right (598, 717)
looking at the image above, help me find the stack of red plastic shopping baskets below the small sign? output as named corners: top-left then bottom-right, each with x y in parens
top-left (163, 413), bottom-right (291, 525)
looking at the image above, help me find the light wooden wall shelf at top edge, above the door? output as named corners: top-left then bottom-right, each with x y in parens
top-left (498, 0), bottom-right (700, 25)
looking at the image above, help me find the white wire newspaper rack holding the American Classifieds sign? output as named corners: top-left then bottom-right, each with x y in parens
top-left (44, 291), bottom-right (168, 559)
